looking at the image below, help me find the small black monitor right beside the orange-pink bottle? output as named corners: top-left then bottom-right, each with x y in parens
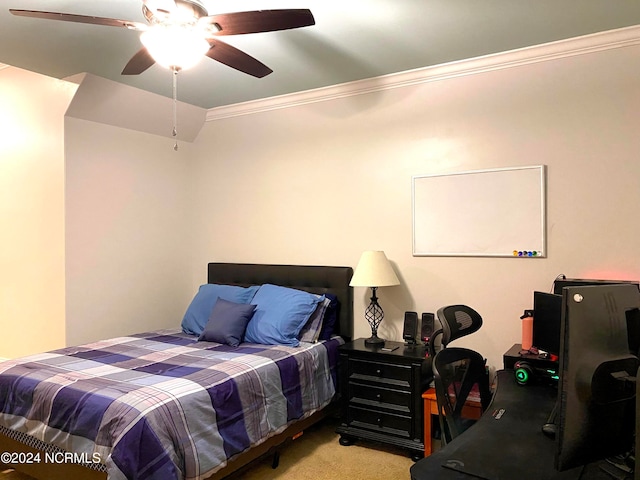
top-left (533, 292), bottom-right (562, 355)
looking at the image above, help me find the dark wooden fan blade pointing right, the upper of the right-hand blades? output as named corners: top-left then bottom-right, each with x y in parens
top-left (201, 9), bottom-right (316, 35)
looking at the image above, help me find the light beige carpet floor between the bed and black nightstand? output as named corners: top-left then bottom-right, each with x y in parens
top-left (0, 419), bottom-right (413, 480)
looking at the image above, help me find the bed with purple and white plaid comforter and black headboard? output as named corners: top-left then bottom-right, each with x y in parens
top-left (0, 263), bottom-right (353, 480)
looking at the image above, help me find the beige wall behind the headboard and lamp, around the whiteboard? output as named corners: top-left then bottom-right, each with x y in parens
top-left (193, 42), bottom-right (640, 368)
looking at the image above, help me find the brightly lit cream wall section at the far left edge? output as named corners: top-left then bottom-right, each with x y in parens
top-left (0, 68), bottom-right (76, 358)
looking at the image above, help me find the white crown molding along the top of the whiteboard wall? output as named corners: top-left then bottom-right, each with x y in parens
top-left (206, 26), bottom-right (640, 122)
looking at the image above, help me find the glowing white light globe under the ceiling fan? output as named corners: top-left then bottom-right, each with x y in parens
top-left (140, 24), bottom-right (210, 70)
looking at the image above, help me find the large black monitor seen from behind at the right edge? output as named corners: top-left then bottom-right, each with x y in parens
top-left (556, 284), bottom-right (640, 470)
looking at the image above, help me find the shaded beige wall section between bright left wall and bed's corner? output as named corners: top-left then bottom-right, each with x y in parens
top-left (65, 116), bottom-right (192, 345)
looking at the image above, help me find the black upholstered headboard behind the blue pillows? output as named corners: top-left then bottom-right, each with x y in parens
top-left (207, 263), bottom-right (353, 340)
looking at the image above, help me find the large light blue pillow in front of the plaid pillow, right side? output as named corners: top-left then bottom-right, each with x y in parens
top-left (244, 283), bottom-right (325, 347)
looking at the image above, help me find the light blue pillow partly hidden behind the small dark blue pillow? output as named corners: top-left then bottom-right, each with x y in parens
top-left (182, 283), bottom-right (259, 335)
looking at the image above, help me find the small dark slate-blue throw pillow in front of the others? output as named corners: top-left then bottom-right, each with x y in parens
top-left (198, 298), bottom-right (256, 347)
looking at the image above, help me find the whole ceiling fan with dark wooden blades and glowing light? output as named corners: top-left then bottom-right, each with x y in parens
top-left (9, 0), bottom-right (315, 78)
